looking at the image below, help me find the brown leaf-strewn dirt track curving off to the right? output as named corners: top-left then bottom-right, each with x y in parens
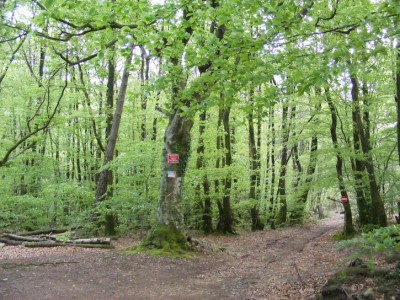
top-left (0, 214), bottom-right (345, 300)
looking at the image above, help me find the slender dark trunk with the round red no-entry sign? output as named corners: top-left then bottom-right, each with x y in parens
top-left (326, 91), bottom-right (355, 236)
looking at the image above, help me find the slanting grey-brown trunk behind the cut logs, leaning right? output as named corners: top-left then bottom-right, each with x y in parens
top-left (95, 47), bottom-right (133, 235)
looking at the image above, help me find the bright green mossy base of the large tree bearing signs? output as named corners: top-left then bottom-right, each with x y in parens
top-left (125, 224), bottom-right (196, 259)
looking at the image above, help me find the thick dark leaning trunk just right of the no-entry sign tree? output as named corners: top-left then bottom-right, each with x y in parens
top-left (350, 67), bottom-right (387, 226)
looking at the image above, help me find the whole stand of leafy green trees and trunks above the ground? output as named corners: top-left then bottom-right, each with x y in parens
top-left (0, 0), bottom-right (400, 245)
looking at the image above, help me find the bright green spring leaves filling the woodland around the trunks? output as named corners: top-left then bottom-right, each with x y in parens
top-left (0, 0), bottom-right (400, 237)
